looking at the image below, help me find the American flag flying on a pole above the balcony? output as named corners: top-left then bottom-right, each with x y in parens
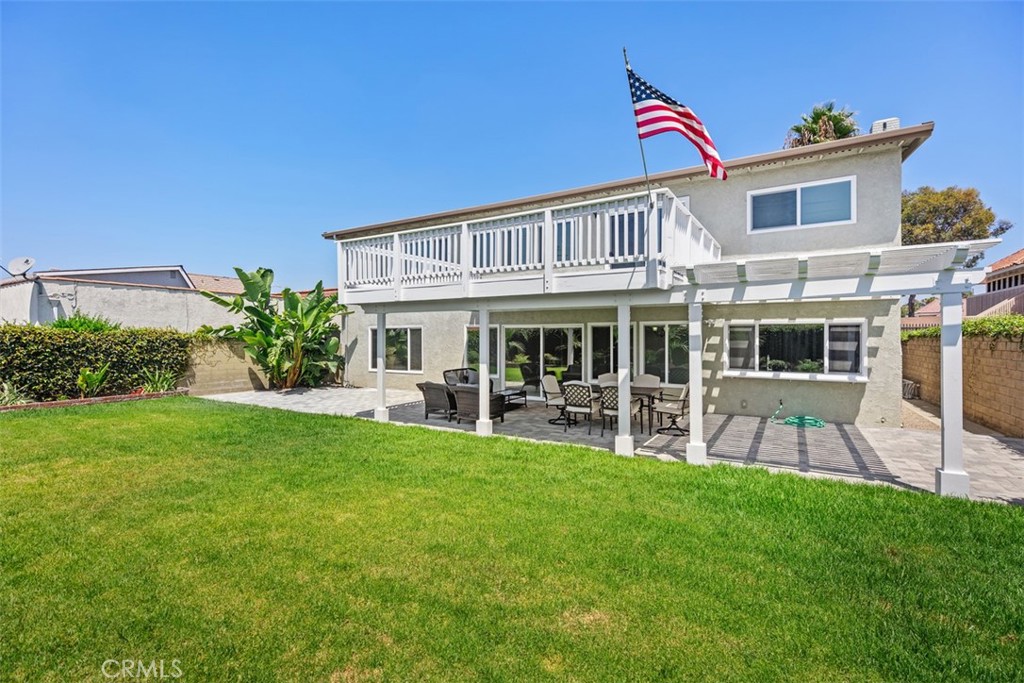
top-left (627, 68), bottom-right (728, 180)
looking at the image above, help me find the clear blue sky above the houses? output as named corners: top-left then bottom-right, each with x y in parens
top-left (0, 2), bottom-right (1024, 288)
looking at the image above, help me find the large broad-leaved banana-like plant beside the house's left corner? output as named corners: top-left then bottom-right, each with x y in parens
top-left (203, 268), bottom-right (346, 389)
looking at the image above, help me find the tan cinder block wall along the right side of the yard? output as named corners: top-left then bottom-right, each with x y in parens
top-left (903, 337), bottom-right (1024, 437)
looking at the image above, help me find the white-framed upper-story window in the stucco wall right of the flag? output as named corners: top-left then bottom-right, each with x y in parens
top-left (746, 175), bottom-right (857, 232)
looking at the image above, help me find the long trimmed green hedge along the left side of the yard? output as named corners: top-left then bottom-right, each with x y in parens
top-left (0, 325), bottom-right (196, 400)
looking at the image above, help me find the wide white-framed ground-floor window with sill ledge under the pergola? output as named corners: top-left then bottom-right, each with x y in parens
top-left (726, 321), bottom-right (865, 376)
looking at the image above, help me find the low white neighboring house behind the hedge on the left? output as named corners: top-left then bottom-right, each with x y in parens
top-left (0, 265), bottom-right (243, 332)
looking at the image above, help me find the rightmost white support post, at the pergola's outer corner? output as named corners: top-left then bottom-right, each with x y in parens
top-left (935, 292), bottom-right (971, 498)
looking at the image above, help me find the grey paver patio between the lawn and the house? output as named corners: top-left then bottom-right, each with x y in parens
top-left (205, 387), bottom-right (1024, 505)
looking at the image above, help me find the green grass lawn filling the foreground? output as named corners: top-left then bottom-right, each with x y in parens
top-left (0, 398), bottom-right (1024, 681)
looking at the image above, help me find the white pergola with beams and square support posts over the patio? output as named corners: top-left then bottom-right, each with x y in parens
top-left (360, 240), bottom-right (999, 497)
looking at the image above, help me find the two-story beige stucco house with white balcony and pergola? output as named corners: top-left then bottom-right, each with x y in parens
top-left (324, 123), bottom-right (998, 495)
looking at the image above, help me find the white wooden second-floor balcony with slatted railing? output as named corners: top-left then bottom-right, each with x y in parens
top-left (338, 189), bottom-right (722, 304)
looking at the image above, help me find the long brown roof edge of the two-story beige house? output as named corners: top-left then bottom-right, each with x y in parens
top-left (324, 122), bottom-right (935, 240)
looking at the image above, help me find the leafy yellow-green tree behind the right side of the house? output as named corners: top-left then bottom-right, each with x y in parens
top-left (901, 185), bottom-right (1013, 268)
